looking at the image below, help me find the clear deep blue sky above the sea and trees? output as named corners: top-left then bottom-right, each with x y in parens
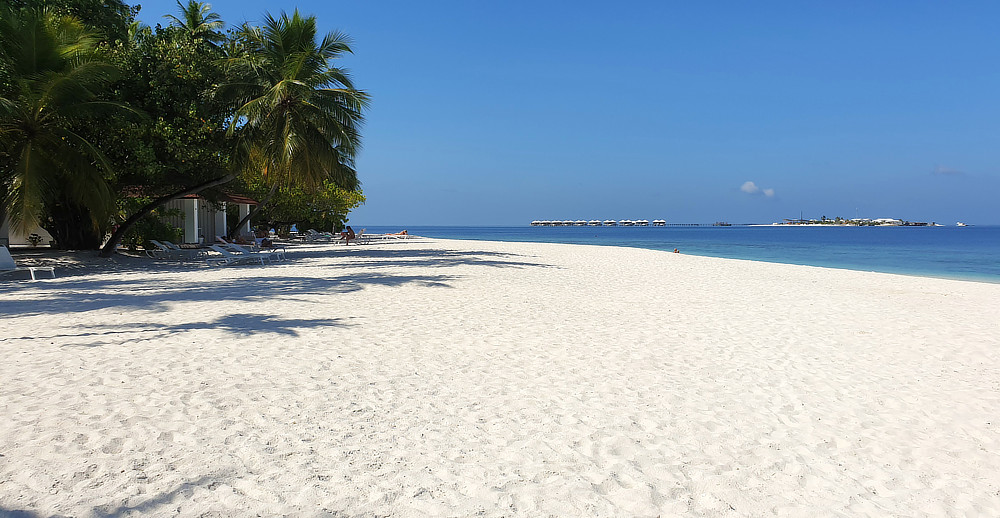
top-left (139, 0), bottom-right (1000, 227)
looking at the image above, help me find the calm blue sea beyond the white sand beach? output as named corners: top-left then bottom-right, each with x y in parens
top-left (367, 226), bottom-right (1000, 283)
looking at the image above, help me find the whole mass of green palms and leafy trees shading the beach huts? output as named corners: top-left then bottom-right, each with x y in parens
top-left (0, 0), bottom-right (369, 256)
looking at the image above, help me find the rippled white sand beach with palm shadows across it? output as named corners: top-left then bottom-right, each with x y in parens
top-left (0, 239), bottom-right (1000, 517)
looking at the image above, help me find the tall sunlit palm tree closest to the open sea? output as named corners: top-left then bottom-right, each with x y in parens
top-left (218, 10), bottom-right (368, 234)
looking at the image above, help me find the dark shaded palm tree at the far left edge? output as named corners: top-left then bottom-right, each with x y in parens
top-left (0, 6), bottom-right (121, 246)
